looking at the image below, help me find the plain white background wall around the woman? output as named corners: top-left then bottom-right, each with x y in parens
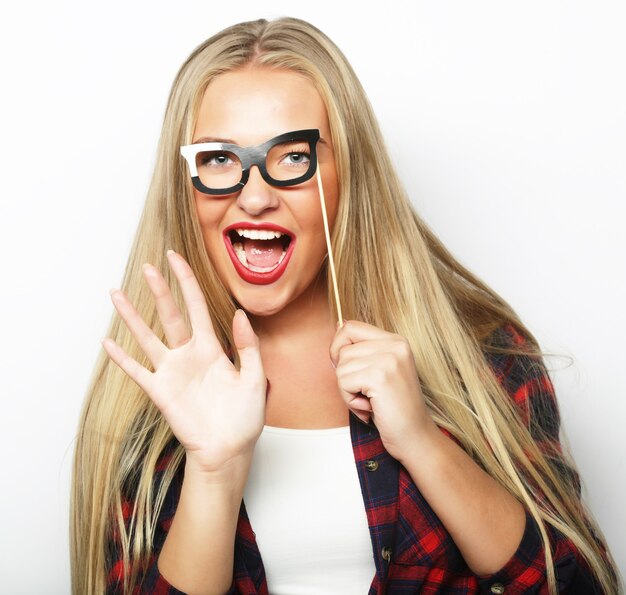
top-left (0, 0), bottom-right (626, 595)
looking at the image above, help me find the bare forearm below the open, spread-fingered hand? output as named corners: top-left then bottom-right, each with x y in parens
top-left (158, 458), bottom-right (250, 595)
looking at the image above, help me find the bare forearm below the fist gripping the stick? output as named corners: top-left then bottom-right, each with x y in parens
top-left (401, 424), bottom-right (525, 575)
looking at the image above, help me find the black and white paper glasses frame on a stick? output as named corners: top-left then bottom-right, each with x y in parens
top-left (180, 128), bottom-right (320, 195)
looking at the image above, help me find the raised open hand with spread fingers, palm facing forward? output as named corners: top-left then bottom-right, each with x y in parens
top-left (103, 251), bottom-right (267, 472)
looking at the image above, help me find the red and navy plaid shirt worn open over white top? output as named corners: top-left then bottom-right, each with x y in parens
top-left (107, 326), bottom-right (600, 595)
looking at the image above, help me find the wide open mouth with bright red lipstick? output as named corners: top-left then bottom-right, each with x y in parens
top-left (224, 223), bottom-right (295, 284)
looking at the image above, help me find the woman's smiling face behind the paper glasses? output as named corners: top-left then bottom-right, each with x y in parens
top-left (193, 67), bottom-right (339, 316)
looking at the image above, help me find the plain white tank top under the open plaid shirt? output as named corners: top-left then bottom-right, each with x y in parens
top-left (244, 426), bottom-right (376, 595)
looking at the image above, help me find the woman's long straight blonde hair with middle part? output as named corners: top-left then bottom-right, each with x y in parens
top-left (71, 18), bottom-right (618, 595)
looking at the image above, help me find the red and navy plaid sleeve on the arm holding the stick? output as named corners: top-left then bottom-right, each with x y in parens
top-left (479, 325), bottom-right (601, 595)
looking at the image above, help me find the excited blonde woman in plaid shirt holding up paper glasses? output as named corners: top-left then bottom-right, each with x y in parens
top-left (72, 19), bottom-right (617, 594)
